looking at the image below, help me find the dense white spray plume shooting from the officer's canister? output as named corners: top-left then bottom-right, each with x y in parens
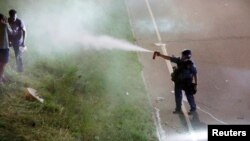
top-left (23, 0), bottom-right (152, 52)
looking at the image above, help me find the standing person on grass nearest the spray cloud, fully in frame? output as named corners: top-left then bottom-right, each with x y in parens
top-left (8, 9), bottom-right (26, 72)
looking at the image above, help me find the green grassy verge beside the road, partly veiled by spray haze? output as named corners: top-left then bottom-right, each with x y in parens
top-left (0, 0), bottom-right (156, 141)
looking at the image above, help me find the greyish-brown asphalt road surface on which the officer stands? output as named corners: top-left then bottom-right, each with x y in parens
top-left (125, 0), bottom-right (250, 141)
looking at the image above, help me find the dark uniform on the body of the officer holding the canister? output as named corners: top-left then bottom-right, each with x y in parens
top-left (170, 57), bottom-right (197, 113)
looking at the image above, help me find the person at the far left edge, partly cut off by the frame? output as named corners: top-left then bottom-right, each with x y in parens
top-left (0, 13), bottom-right (11, 84)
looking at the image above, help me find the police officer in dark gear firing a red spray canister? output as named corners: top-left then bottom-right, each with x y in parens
top-left (155, 49), bottom-right (197, 114)
